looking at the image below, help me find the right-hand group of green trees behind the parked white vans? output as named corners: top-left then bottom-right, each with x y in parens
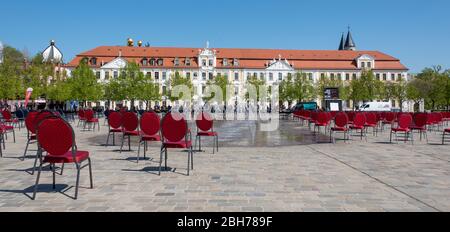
top-left (280, 69), bottom-right (450, 110)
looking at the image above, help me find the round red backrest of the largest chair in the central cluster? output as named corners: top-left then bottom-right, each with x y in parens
top-left (161, 113), bottom-right (188, 142)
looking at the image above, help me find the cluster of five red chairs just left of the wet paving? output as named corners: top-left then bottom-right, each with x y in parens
top-left (106, 112), bottom-right (219, 175)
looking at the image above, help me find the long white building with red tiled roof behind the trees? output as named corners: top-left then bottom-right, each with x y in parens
top-left (65, 33), bottom-right (408, 111)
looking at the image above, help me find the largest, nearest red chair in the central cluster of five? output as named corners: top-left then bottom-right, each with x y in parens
top-left (159, 113), bottom-right (194, 176)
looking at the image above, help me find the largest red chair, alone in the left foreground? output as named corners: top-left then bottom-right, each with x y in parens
top-left (32, 116), bottom-right (94, 200)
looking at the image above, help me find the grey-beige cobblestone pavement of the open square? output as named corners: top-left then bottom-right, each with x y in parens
top-left (0, 119), bottom-right (450, 212)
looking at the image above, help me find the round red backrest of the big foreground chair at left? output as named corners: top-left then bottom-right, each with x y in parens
top-left (36, 116), bottom-right (75, 156)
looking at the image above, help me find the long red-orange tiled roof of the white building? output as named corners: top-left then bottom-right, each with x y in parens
top-left (67, 46), bottom-right (407, 70)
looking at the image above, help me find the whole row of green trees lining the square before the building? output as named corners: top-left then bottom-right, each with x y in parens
top-left (0, 46), bottom-right (450, 109)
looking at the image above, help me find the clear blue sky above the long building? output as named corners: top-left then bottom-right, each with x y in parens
top-left (0, 0), bottom-right (450, 72)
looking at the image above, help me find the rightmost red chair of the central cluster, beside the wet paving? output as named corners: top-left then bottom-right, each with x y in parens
top-left (194, 112), bottom-right (219, 154)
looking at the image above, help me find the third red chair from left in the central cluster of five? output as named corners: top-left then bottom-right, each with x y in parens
top-left (137, 112), bottom-right (161, 163)
